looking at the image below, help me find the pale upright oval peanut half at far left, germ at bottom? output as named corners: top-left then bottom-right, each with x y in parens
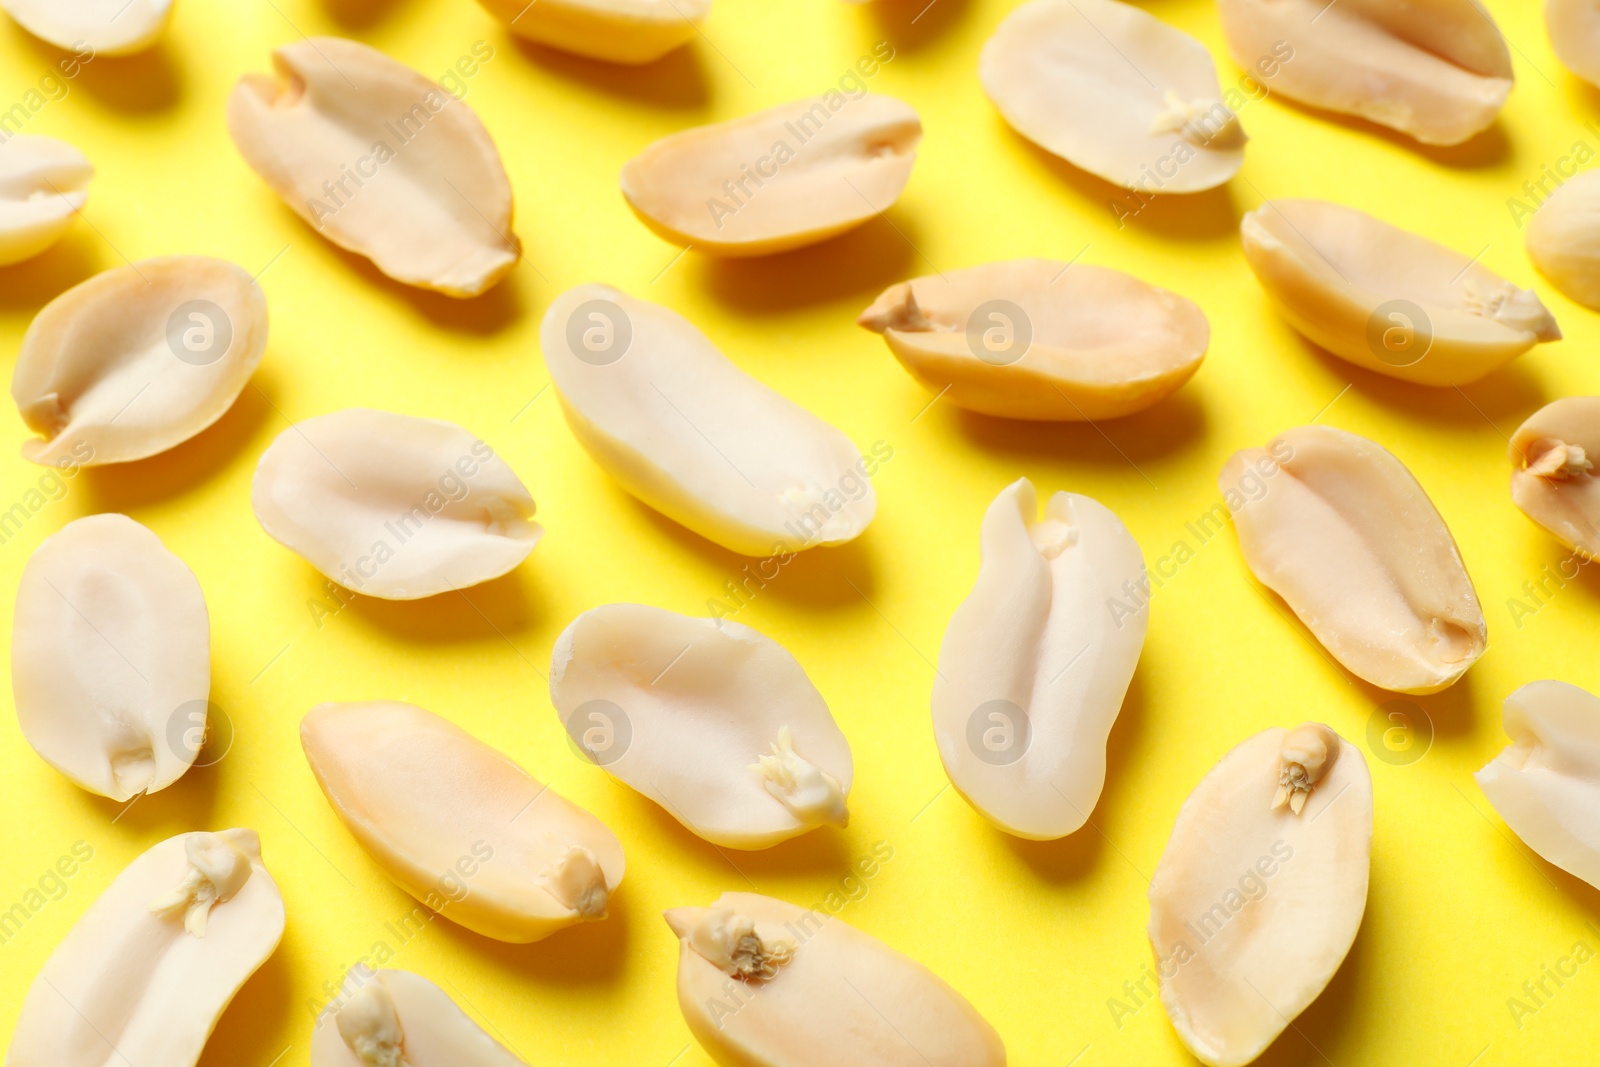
top-left (11, 515), bottom-right (211, 800)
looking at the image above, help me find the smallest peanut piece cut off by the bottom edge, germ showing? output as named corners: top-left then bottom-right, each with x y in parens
top-left (310, 968), bottom-right (528, 1067)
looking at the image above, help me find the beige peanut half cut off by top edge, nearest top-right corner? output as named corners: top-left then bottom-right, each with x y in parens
top-left (1218, 0), bottom-right (1514, 144)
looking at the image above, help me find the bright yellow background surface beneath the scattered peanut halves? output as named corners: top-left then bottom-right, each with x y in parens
top-left (0, 0), bottom-right (1600, 1067)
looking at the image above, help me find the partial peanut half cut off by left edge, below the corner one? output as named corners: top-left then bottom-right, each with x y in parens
top-left (0, 133), bottom-right (94, 267)
